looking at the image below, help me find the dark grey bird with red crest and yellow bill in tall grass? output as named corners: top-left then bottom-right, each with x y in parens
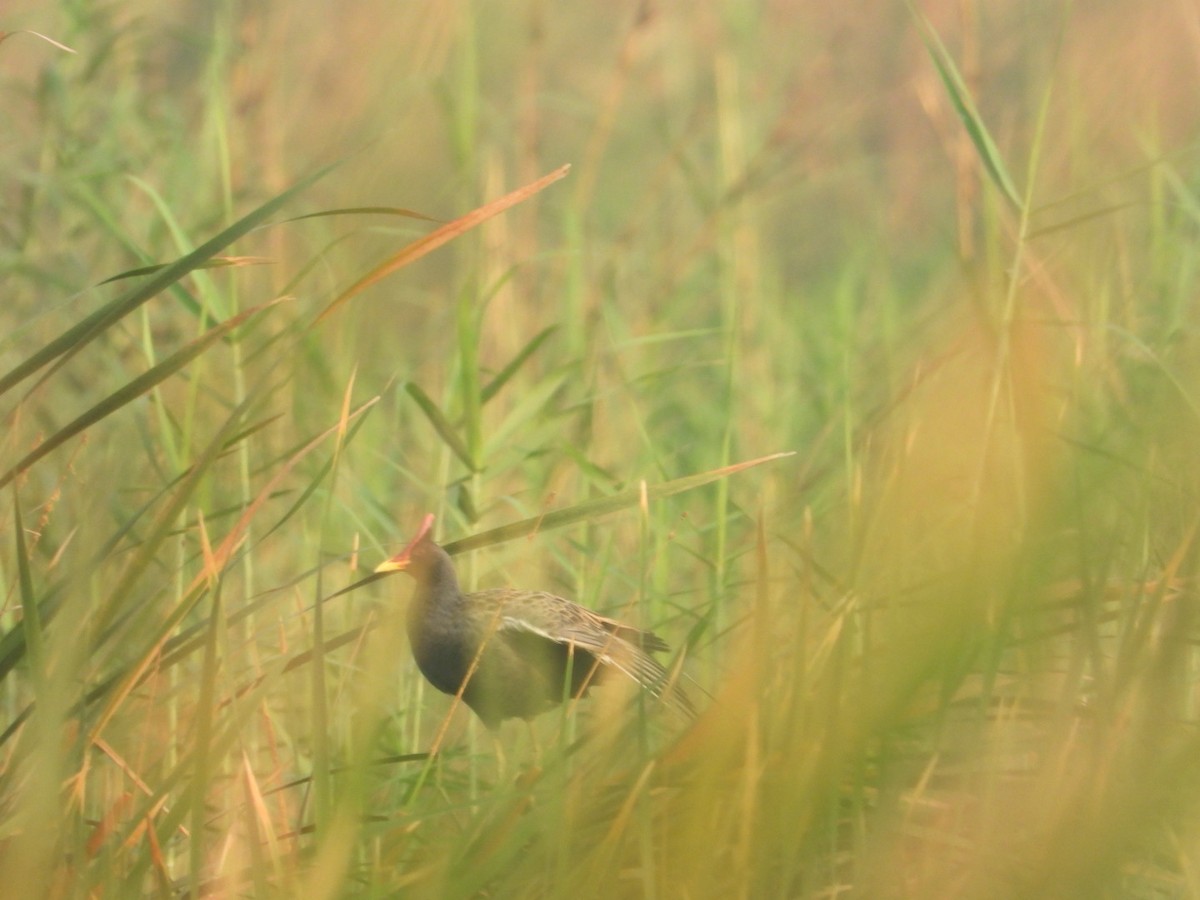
top-left (374, 514), bottom-right (696, 732)
